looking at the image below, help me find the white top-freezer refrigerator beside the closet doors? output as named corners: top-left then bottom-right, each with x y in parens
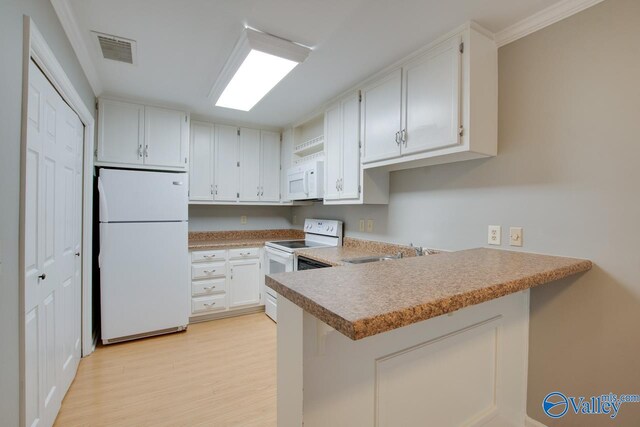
top-left (98, 169), bottom-right (190, 344)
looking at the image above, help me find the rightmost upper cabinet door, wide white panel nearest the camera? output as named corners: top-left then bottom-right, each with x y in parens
top-left (402, 37), bottom-right (462, 154)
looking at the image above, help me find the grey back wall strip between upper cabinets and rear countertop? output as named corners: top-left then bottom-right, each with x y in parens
top-left (189, 205), bottom-right (291, 231)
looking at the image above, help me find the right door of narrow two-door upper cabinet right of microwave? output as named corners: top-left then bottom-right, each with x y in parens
top-left (340, 95), bottom-right (361, 199)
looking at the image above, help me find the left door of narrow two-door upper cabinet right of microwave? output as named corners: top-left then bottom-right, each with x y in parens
top-left (324, 103), bottom-right (342, 200)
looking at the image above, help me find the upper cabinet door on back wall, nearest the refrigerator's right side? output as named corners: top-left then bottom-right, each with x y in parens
top-left (189, 122), bottom-right (215, 200)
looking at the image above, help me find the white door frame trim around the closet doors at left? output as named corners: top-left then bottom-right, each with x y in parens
top-left (19, 15), bottom-right (97, 425)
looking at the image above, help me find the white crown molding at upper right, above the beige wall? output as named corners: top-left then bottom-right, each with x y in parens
top-left (495, 0), bottom-right (604, 47)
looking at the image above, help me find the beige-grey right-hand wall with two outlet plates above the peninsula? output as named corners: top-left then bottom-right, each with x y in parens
top-left (293, 0), bottom-right (640, 427)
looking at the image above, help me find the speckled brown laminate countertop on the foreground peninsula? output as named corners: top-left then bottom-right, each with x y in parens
top-left (266, 248), bottom-right (592, 340)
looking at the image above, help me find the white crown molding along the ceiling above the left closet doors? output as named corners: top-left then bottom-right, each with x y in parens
top-left (51, 0), bottom-right (102, 96)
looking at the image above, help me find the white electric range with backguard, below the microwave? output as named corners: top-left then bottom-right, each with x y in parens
top-left (265, 219), bottom-right (343, 321)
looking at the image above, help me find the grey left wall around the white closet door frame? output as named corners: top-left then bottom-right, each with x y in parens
top-left (0, 0), bottom-right (93, 427)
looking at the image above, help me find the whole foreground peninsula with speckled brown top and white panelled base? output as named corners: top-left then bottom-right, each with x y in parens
top-left (266, 249), bottom-right (592, 427)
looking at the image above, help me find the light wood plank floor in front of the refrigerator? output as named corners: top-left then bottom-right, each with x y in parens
top-left (55, 313), bottom-right (276, 427)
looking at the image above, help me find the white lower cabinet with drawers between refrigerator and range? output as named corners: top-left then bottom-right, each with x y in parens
top-left (191, 248), bottom-right (264, 319)
